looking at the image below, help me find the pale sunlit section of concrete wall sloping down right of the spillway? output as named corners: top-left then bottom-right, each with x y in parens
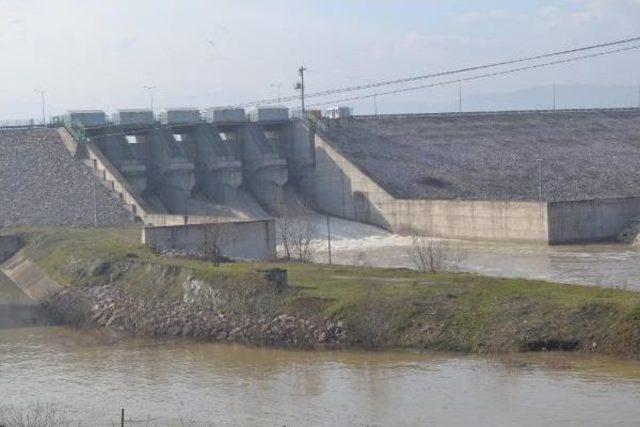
top-left (301, 135), bottom-right (548, 243)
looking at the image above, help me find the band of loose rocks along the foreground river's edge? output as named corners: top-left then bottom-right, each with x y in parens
top-left (49, 286), bottom-right (346, 347)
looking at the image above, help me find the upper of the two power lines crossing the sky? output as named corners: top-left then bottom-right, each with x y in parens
top-left (229, 37), bottom-right (640, 107)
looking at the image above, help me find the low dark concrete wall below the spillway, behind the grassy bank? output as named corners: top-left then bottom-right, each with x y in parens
top-left (142, 220), bottom-right (276, 261)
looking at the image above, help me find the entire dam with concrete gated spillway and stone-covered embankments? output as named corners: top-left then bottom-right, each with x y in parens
top-left (0, 107), bottom-right (640, 259)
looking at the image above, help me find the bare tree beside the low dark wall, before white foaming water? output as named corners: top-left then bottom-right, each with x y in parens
top-left (278, 211), bottom-right (318, 263)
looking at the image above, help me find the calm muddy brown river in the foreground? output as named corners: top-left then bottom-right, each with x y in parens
top-left (0, 328), bottom-right (640, 426)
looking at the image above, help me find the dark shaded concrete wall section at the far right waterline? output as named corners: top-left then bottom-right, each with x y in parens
top-left (548, 197), bottom-right (640, 244)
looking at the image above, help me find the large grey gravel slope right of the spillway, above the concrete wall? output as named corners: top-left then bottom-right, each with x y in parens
top-left (325, 109), bottom-right (640, 201)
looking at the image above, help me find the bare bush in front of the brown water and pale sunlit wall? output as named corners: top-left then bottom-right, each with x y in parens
top-left (408, 235), bottom-right (464, 273)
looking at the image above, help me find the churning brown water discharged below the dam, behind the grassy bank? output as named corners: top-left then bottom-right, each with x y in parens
top-left (313, 216), bottom-right (640, 291)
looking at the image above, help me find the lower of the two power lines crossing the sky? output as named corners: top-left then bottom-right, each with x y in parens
top-left (308, 45), bottom-right (640, 107)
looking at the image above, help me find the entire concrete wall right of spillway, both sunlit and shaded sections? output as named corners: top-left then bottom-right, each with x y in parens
top-left (301, 130), bottom-right (640, 244)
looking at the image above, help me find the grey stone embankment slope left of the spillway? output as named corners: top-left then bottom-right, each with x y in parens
top-left (0, 129), bottom-right (133, 226)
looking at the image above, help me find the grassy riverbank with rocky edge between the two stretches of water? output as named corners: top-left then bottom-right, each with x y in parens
top-left (8, 229), bottom-right (640, 357)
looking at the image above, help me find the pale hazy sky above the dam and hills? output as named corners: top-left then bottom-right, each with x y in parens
top-left (0, 0), bottom-right (640, 118)
